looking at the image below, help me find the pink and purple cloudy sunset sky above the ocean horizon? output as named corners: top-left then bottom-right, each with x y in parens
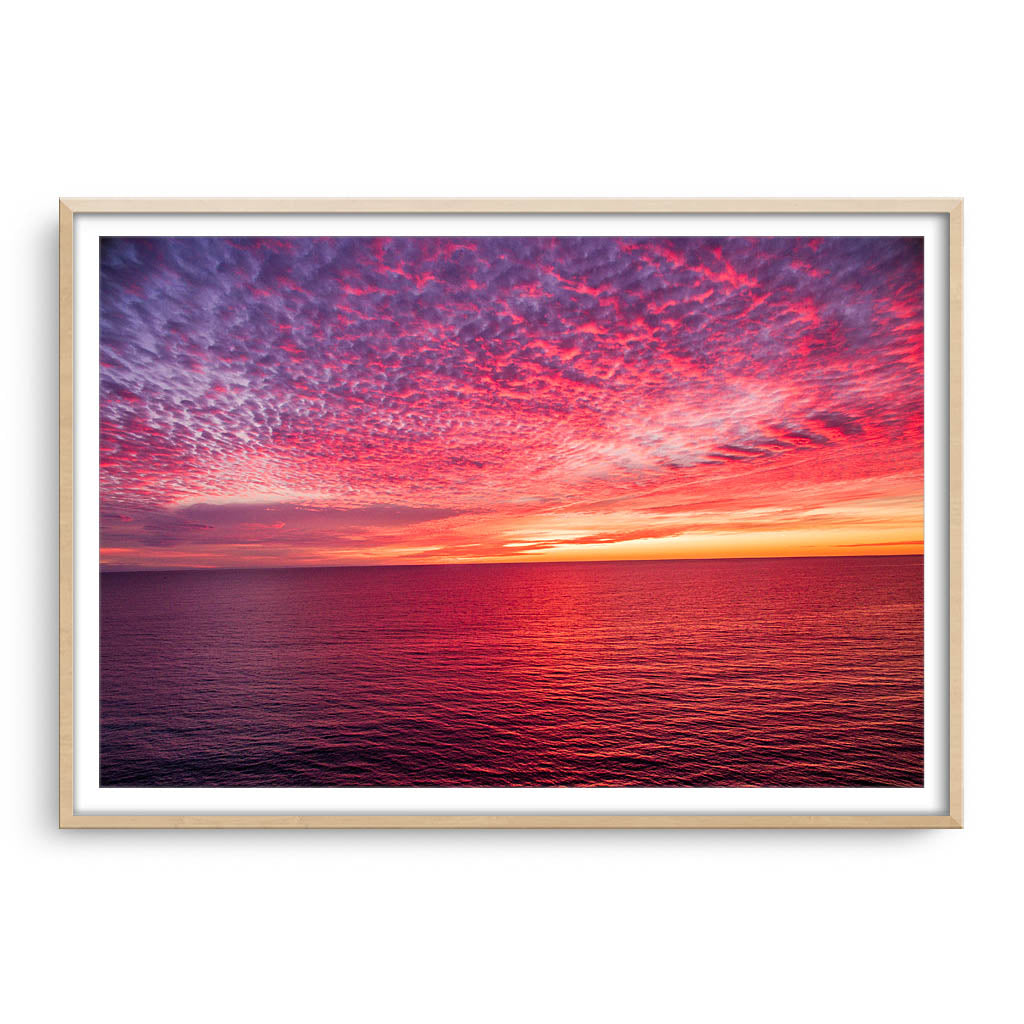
top-left (100, 237), bottom-right (924, 569)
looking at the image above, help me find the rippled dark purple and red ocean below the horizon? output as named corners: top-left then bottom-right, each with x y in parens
top-left (100, 556), bottom-right (924, 786)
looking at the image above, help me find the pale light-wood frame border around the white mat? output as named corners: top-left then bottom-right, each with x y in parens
top-left (59, 199), bottom-right (964, 828)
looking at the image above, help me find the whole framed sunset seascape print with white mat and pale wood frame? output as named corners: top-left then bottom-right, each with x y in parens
top-left (59, 199), bottom-right (963, 828)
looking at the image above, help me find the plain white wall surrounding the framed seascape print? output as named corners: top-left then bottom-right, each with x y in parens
top-left (0, 0), bottom-right (1024, 1022)
